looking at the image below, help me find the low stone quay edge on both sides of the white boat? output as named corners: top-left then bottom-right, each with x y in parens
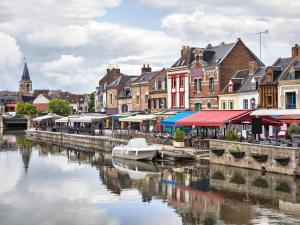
top-left (26, 130), bottom-right (209, 160)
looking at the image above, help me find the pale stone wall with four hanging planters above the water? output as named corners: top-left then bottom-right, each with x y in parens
top-left (209, 140), bottom-right (300, 175)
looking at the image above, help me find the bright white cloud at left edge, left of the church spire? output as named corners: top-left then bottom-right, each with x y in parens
top-left (0, 32), bottom-right (22, 71)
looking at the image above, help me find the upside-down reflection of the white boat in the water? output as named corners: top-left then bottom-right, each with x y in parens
top-left (112, 158), bottom-right (159, 180)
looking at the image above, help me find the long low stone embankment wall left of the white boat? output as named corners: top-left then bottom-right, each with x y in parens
top-left (26, 130), bottom-right (128, 151)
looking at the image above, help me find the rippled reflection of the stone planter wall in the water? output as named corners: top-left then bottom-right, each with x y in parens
top-left (210, 164), bottom-right (300, 203)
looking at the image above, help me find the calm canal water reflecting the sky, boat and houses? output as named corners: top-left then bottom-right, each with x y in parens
top-left (0, 133), bottom-right (300, 225)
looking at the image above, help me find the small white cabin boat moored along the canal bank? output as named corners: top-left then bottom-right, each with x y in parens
top-left (112, 138), bottom-right (161, 160)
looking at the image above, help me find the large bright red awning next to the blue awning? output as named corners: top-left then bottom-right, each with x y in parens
top-left (175, 110), bottom-right (252, 127)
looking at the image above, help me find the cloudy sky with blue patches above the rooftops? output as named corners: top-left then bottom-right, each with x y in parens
top-left (0, 0), bottom-right (300, 93)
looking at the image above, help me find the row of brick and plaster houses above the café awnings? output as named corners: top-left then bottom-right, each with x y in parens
top-left (95, 39), bottom-right (300, 115)
